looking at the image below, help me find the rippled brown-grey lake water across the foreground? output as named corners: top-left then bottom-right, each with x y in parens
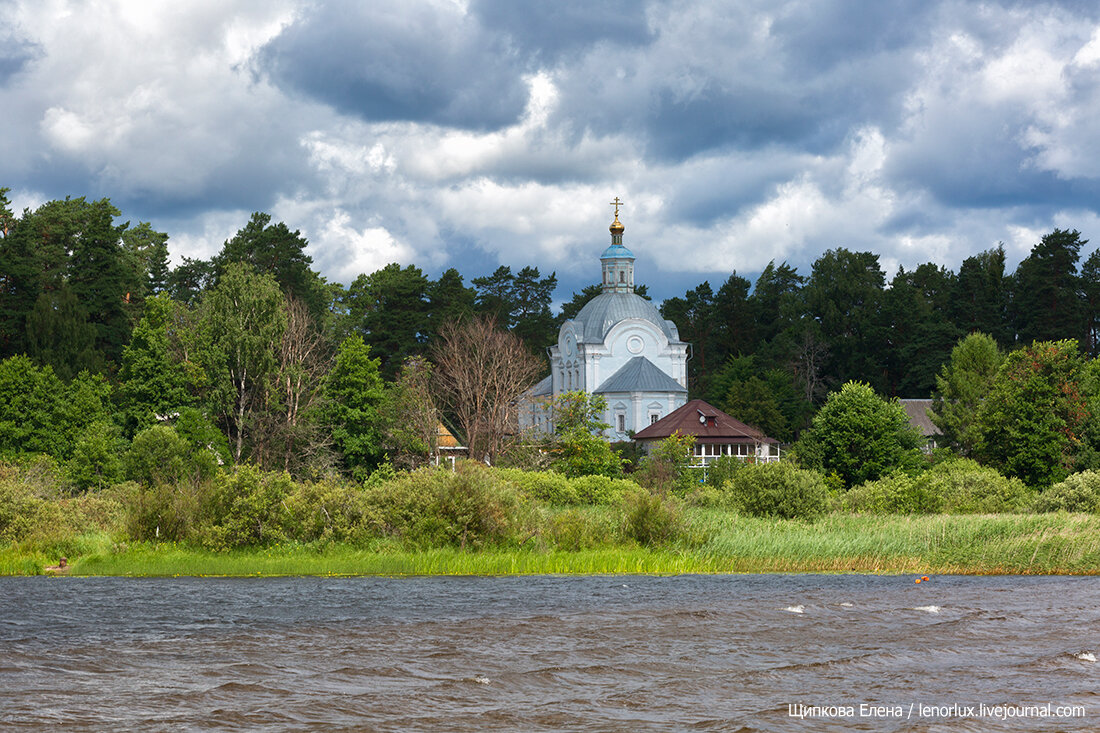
top-left (0, 576), bottom-right (1100, 731)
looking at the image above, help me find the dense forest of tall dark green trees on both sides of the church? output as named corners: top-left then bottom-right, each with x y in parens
top-left (0, 189), bottom-right (1100, 488)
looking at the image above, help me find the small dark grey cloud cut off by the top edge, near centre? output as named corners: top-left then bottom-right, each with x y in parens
top-left (470, 0), bottom-right (656, 65)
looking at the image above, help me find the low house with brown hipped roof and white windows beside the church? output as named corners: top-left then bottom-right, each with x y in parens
top-left (634, 400), bottom-right (779, 463)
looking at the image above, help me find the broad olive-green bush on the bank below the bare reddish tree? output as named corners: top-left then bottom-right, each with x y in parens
top-left (366, 461), bottom-right (535, 548)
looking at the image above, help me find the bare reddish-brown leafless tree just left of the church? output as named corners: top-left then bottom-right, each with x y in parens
top-left (433, 317), bottom-right (541, 460)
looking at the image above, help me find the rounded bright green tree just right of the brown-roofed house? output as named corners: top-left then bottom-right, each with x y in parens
top-left (794, 382), bottom-right (924, 488)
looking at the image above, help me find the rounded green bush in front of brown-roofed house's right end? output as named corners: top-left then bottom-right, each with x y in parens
top-left (725, 462), bottom-right (828, 519)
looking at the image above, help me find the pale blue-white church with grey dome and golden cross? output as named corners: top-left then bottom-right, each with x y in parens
top-left (519, 198), bottom-right (688, 440)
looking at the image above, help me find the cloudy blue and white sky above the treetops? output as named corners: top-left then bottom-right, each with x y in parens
top-left (0, 0), bottom-right (1100, 302)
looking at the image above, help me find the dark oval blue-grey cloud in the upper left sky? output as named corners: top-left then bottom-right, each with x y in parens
top-left (257, 2), bottom-right (527, 130)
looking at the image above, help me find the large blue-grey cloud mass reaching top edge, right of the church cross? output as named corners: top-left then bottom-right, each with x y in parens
top-left (550, 3), bottom-right (926, 162)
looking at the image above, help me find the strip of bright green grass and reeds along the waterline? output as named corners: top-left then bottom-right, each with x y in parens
top-left (8, 510), bottom-right (1100, 577)
